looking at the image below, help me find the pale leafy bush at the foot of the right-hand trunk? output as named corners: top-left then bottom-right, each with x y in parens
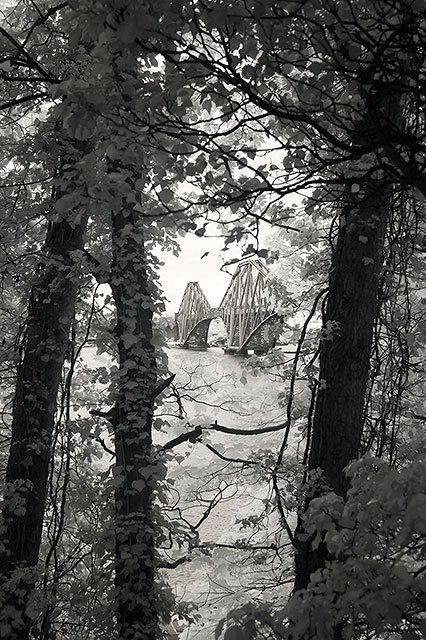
top-left (298, 446), bottom-right (426, 637)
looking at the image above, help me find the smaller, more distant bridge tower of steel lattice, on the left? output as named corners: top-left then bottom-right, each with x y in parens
top-left (175, 282), bottom-right (219, 349)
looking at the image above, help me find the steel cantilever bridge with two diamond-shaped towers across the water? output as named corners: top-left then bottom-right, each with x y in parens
top-left (176, 259), bottom-right (277, 354)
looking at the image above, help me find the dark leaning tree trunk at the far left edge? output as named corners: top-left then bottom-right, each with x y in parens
top-left (0, 209), bottom-right (86, 640)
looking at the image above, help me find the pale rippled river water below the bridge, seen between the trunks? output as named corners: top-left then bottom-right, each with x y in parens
top-left (162, 347), bottom-right (294, 640)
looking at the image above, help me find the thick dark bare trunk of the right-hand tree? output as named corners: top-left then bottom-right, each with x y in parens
top-left (295, 178), bottom-right (391, 590)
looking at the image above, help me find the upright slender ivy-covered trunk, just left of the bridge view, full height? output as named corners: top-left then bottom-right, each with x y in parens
top-left (88, 5), bottom-right (161, 640)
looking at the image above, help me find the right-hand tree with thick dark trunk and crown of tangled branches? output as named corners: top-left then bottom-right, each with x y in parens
top-left (140, 1), bottom-right (425, 637)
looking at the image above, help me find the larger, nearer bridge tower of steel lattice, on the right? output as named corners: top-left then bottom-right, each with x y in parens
top-left (219, 258), bottom-right (277, 354)
